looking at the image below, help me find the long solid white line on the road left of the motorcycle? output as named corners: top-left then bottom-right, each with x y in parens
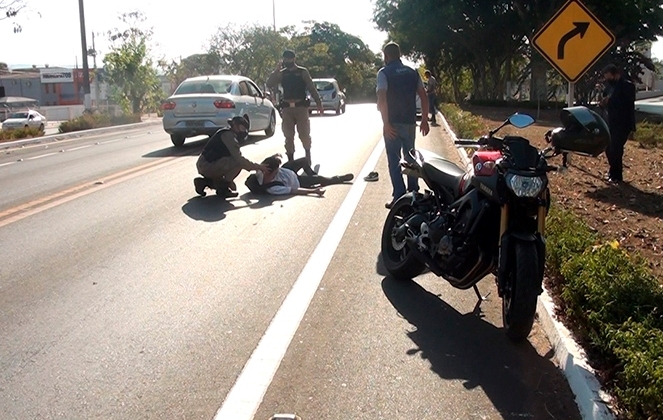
top-left (214, 139), bottom-right (384, 420)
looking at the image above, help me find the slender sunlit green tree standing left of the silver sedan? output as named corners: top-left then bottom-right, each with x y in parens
top-left (104, 12), bottom-right (165, 114)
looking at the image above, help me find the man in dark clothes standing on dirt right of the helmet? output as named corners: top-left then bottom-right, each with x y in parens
top-left (601, 64), bottom-right (635, 183)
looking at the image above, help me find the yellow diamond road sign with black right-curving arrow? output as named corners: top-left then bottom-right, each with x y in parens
top-left (532, 0), bottom-right (615, 82)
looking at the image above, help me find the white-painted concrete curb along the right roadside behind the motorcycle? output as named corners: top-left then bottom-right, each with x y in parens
top-left (440, 110), bottom-right (615, 420)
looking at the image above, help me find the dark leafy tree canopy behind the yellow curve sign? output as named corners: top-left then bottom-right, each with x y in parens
top-left (374, 0), bottom-right (663, 103)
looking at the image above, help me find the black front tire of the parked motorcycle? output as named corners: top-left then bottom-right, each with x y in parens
top-left (502, 241), bottom-right (543, 341)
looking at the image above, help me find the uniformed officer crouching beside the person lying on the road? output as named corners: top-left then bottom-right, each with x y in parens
top-left (193, 117), bottom-right (269, 198)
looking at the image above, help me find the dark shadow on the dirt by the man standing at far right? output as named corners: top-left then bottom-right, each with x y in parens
top-left (585, 182), bottom-right (663, 217)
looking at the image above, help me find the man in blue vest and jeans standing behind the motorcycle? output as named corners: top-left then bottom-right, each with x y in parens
top-left (377, 42), bottom-right (430, 209)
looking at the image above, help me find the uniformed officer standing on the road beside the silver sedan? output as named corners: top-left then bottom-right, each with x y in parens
top-left (267, 50), bottom-right (323, 165)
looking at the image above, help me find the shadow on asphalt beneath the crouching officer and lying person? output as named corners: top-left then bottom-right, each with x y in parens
top-left (182, 191), bottom-right (324, 222)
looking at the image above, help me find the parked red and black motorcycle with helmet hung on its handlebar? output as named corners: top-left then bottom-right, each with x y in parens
top-left (382, 106), bottom-right (610, 341)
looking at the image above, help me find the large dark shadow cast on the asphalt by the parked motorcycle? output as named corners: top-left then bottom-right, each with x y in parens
top-left (382, 276), bottom-right (580, 419)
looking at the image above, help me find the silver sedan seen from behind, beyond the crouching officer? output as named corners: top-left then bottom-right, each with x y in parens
top-left (161, 75), bottom-right (276, 147)
